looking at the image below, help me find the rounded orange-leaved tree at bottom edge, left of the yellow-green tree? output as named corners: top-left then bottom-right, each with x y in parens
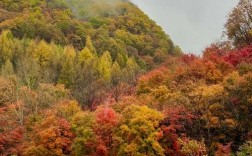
top-left (23, 116), bottom-right (74, 156)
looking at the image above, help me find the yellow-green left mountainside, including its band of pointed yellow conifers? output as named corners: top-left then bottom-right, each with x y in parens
top-left (0, 0), bottom-right (180, 107)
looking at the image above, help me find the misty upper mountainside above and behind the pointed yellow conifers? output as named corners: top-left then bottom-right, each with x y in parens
top-left (0, 0), bottom-right (180, 67)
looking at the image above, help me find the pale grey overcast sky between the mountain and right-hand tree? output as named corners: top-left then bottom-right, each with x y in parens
top-left (132, 0), bottom-right (239, 54)
